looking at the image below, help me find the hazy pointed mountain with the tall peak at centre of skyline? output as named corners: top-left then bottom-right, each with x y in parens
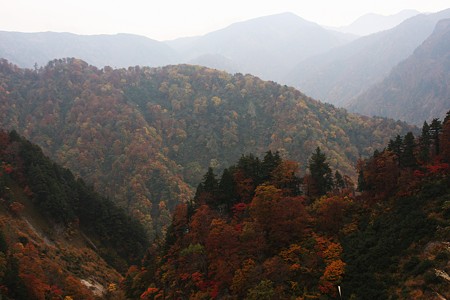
top-left (165, 13), bottom-right (353, 81)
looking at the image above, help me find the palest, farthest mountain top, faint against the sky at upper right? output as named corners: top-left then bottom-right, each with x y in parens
top-left (336, 9), bottom-right (420, 36)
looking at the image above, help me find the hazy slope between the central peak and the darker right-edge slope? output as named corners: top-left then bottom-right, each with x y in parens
top-left (285, 9), bottom-right (450, 107)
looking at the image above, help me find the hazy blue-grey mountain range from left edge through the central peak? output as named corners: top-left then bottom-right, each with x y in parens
top-left (0, 13), bottom-right (355, 81)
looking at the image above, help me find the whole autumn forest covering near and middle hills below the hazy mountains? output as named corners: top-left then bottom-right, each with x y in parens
top-left (0, 59), bottom-right (450, 300)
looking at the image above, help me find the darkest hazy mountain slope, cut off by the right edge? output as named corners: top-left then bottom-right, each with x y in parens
top-left (348, 19), bottom-right (450, 125)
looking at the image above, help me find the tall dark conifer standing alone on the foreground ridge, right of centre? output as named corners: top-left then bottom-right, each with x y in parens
top-left (309, 147), bottom-right (333, 196)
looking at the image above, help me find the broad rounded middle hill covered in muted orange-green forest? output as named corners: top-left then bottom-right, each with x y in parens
top-left (0, 59), bottom-right (414, 237)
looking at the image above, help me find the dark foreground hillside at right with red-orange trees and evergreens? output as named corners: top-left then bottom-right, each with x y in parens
top-left (123, 112), bottom-right (450, 299)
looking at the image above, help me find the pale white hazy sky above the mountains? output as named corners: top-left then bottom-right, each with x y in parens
top-left (0, 0), bottom-right (450, 40)
